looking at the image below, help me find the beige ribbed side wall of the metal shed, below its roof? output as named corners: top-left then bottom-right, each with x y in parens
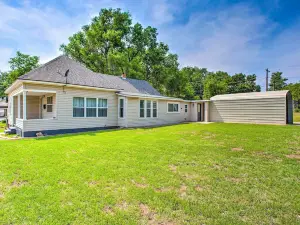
top-left (210, 97), bottom-right (286, 124)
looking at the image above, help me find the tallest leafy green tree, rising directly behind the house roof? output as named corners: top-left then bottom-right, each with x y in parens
top-left (60, 9), bottom-right (178, 92)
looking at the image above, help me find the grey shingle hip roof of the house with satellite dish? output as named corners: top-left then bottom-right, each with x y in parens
top-left (19, 56), bottom-right (161, 95)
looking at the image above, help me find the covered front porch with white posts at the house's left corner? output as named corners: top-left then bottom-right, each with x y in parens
top-left (11, 90), bottom-right (57, 129)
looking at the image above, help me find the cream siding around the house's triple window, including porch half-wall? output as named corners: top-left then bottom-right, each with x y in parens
top-left (23, 84), bottom-right (118, 132)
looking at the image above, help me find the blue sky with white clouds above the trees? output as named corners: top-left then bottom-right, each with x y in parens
top-left (0, 0), bottom-right (300, 87)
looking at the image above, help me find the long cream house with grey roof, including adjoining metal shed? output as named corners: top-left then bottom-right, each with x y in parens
top-left (6, 56), bottom-right (292, 137)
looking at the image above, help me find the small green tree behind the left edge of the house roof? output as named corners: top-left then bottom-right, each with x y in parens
top-left (0, 51), bottom-right (39, 96)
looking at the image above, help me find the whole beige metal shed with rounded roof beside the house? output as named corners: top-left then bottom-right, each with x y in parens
top-left (210, 90), bottom-right (293, 124)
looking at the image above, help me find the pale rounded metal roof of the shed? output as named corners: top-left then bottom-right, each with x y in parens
top-left (210, 90), bottom-right (289, 101)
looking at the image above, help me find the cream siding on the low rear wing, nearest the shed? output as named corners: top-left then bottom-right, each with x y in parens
top-left (127, 98), bottom-right (191, 127)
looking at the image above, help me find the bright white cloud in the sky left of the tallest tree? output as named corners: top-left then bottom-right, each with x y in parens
top-left (0, 2), bottom-right (94, 68)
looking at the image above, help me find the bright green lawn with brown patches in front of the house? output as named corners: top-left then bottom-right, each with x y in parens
top-left (0, 123), bottom-right (300, 224)
